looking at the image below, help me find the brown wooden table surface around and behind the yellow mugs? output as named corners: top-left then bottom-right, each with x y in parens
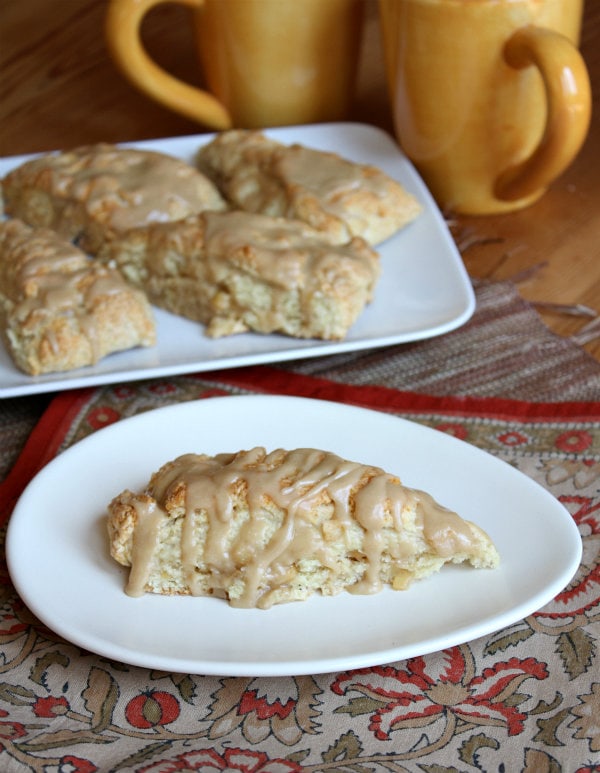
top-left (0, 0), bottom-right (600, 360)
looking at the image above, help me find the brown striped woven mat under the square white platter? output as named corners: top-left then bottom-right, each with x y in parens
top-left (0, 281), bottom-right (600, 480)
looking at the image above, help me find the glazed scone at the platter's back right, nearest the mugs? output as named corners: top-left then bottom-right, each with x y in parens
top-left (197, 129), bottom-right (421, 245)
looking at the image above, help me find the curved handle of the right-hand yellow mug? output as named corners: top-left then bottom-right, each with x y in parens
top-left (494, 26), bottom-right (592, 201)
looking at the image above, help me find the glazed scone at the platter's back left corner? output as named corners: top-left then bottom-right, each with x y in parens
top-left (2, 144), bottom-right (226, 254)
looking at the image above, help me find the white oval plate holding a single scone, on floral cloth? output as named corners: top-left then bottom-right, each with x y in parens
top-left (7, 395), bottom-right (581, 676)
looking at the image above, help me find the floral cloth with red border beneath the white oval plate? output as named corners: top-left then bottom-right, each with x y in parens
top-left (0, 367), bottom-right (600, 773)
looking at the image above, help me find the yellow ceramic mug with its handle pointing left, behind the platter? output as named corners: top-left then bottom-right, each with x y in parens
top-left (106, 0), bottom-right (362, 129)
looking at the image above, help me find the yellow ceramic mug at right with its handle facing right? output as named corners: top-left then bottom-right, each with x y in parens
top-left (379, 0), bottom-right (591, 214)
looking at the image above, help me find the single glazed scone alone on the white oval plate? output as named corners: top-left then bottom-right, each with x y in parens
top-left (107, 447), bottom-right (499, 609)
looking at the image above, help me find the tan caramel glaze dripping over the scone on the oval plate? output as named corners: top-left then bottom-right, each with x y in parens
top-left (127, 447), bottom-right (476, 608)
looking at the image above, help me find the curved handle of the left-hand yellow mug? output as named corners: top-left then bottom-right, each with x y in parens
top-left (105, 0), bottom-right (233, 130)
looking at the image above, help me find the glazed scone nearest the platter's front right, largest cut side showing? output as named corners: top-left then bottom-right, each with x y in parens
top-left (98, 211), bottom-right (380, 339)
